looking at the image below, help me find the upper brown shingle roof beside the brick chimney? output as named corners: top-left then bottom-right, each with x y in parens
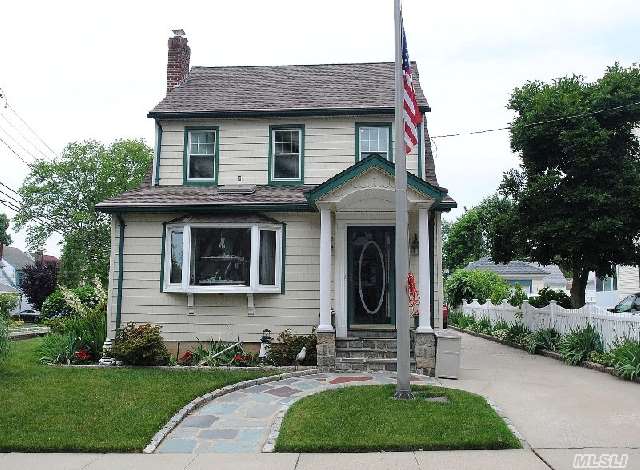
top-left (149, 62), bottom-right (429, 117)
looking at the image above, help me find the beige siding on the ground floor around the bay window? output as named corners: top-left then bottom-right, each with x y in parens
top-left (108, 213), bottom-right (320, 341)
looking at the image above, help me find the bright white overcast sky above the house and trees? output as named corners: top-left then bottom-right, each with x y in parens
top-left (0, 0), bottom-right (640, 254)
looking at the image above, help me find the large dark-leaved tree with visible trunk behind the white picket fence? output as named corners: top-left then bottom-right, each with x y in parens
top-left (491, 64), bottom-right (640, 307)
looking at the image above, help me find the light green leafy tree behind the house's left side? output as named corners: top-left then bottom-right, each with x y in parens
top-left (14, 140), bottom-right (153, 286)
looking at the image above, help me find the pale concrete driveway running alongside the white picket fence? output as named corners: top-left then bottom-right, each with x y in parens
top-left (441, 334), bottom-right (640, 469)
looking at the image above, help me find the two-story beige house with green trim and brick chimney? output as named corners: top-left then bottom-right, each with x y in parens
top-left (98, 34), bottom-right (455, 368)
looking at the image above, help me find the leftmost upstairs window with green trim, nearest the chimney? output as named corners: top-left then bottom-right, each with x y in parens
top-left (185, 129), bottom-right (218, 183)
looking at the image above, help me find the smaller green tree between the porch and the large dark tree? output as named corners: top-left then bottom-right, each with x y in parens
top-left (442, 194), bottom-right (512, 272)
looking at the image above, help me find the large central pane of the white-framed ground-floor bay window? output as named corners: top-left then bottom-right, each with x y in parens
top-left (190, 227), bottom-right (251, 286)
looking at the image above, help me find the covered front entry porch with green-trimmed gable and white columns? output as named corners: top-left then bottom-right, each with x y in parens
top-left (309, 159), bottom-right (450, 370)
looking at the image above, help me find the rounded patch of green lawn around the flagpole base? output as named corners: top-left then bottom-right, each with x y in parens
top-left (276, 385), bottom-right (521, 452)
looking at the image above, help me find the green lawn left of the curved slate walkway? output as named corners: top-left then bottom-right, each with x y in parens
top-left (0, 339), bottom-right (267, 452)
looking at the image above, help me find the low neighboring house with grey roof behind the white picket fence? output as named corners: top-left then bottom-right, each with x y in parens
top-left (465, 257), bottom-right (567, 296)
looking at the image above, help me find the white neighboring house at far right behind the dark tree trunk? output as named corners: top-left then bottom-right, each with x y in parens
top-left (585, 266), bottom-right (640, 308)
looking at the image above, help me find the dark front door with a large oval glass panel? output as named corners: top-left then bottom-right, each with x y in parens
top-left (347, 226), bottom-right (395, 326)
